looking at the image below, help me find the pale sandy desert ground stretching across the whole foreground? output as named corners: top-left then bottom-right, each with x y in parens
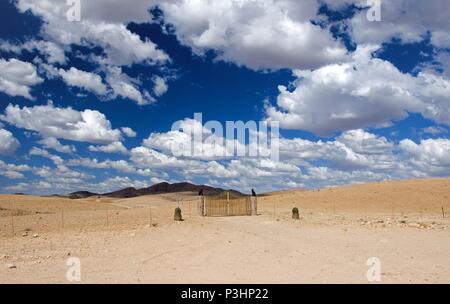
top-left (0, 180), bottom-right (450, 283)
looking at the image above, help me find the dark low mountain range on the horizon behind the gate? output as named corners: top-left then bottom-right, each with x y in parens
top-left (69, 182), bottom-right (243, 199)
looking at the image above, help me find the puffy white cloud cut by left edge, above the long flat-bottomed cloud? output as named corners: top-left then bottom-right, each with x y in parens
top-left (0, 58), bottom-right (43, 99)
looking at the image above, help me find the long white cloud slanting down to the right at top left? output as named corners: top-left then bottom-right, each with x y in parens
top-left (16, 0), bottom-right (168, 66)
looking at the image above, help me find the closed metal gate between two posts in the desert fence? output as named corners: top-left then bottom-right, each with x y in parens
top-left (204, 197), bottom-right (252, 216)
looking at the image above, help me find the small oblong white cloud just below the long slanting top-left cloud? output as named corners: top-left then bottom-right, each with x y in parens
top-left (59, 67), bottom-right (106, 95)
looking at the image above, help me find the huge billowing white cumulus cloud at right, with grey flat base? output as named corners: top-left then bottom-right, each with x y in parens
top-left (266, 46), bottom-right (450, 136)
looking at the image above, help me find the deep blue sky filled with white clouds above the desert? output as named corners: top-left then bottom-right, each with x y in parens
top-left (0, 0), bottom-right (450, 194)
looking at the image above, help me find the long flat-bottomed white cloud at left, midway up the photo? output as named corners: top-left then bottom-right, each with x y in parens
top-left (0, 104), bottom-right (121, 144)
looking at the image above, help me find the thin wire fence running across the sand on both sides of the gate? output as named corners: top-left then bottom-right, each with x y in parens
top-left (0, 200), bottom-right (450, 237)
